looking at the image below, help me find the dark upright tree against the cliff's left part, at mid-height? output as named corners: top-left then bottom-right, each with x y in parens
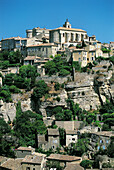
top-left (32, 80), bottom-right (49, 101)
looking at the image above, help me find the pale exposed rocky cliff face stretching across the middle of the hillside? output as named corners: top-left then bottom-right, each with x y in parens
top-left (0, 61), bottom-right (114, 121)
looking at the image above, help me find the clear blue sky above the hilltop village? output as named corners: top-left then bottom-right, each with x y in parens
top-left (0, 0), bottom-right (114, 42)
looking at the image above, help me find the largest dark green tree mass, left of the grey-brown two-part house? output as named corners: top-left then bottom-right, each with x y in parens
top-left (14, 111), bottom-right (46, 147)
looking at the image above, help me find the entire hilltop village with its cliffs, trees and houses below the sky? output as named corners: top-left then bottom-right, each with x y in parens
top-left (0, 19), bottom-right (114, 170)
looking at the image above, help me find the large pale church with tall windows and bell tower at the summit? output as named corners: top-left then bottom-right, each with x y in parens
top-left (49, 20), bottom-right (88, 47)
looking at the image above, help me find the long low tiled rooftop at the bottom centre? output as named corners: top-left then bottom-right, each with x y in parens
top-left (47, 154), bottom-right (81, 162)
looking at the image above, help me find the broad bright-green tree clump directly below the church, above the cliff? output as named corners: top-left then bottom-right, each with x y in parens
top-left (45, 55), bottom-right (71, 77)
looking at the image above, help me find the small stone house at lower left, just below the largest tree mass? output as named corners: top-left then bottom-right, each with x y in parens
top-left (15, 146), bottom-right (35, 158)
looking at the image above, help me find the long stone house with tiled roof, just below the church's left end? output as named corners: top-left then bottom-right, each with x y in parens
top-left (27, 43), bottom-right (58, 58)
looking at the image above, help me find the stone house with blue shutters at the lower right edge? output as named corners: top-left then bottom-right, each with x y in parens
top-left (90, 131), bottom-right (114, 150)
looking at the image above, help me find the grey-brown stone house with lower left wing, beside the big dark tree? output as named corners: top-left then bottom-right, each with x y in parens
top-left (38, 128), bottom-right (60, 150)
